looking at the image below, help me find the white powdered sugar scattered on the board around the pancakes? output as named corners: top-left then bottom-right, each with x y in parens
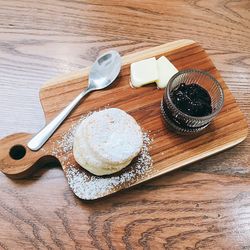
top-left (52, 110), bottom-right (153, 200)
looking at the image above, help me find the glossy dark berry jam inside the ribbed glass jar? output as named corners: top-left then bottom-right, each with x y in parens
top-left (170, 83), bottom-right (212, 117)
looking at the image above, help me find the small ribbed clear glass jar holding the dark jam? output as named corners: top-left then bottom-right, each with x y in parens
top-left (161, 69), bottom-right (224, 134)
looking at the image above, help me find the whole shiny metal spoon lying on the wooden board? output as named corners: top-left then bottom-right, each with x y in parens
top-left (28, 51), bottom-right (121, 151)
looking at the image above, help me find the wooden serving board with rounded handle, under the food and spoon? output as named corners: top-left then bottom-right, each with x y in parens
top-left (0, 40), bottom-right (248, 200)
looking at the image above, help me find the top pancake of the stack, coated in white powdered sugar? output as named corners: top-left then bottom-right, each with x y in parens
top-left (85, 108), bottom-right (143, 164)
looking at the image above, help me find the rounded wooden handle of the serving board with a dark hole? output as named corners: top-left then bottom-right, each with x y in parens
top-left (0, 133), bottom-right (55, 178)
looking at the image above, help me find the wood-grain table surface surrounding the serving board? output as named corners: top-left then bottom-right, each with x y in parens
top-left (0, 0), bottom-right (250, 250)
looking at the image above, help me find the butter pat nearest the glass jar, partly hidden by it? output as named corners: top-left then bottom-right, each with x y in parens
top-left (156, 56), bottom-right (178, 88)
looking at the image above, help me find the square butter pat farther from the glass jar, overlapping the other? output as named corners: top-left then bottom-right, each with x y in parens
top-left (130, 57), bottom-right (158, 88)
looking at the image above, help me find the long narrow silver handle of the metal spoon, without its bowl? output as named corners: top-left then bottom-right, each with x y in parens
top-left (27, 88), bottom-right (91, 151)
